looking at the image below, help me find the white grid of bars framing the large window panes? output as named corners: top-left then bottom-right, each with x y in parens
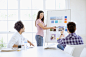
top-left (0, 0), bottom-right (66, 44)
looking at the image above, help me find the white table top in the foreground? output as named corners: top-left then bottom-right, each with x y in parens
top-left (0, 47), bottom-right (72, 57)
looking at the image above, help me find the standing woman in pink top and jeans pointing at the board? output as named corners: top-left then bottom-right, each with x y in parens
top-left (35, 11), bottom-right (56, 46)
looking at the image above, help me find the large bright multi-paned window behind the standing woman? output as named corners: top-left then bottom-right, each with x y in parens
top-left (0, 0), bottom-right (65, 45)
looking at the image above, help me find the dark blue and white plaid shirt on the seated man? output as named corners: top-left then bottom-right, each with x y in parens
top-left (57, 33), bottom-right (84, 47)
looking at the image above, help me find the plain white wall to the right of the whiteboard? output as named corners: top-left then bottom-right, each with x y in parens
top-left (66, 0), bottom-right (86, 44)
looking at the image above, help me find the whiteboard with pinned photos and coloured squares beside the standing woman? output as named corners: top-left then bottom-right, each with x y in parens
top-left (45, 9), bottom-right (71, 43)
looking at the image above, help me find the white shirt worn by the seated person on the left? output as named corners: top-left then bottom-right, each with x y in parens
top-left (7, 32), bottom-right (27, 48)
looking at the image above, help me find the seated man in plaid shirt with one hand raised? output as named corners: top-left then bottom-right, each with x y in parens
top-left (57, 22), bottom-right (84, 50)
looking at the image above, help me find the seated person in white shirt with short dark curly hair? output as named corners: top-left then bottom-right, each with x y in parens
top-left (7, 21), bottom-right (34, 48)
